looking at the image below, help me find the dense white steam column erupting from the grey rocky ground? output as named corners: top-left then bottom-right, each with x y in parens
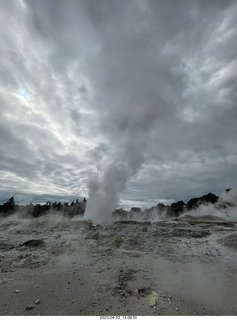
top-left (85, 127), bottom-right (157, 224)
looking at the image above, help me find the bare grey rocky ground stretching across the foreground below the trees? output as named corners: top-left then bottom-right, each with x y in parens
top-left (0, 214), bottom-right (237, 316)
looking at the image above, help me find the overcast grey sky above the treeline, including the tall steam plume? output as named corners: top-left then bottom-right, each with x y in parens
top-left (0, 0), bottom-right (237, 212)
